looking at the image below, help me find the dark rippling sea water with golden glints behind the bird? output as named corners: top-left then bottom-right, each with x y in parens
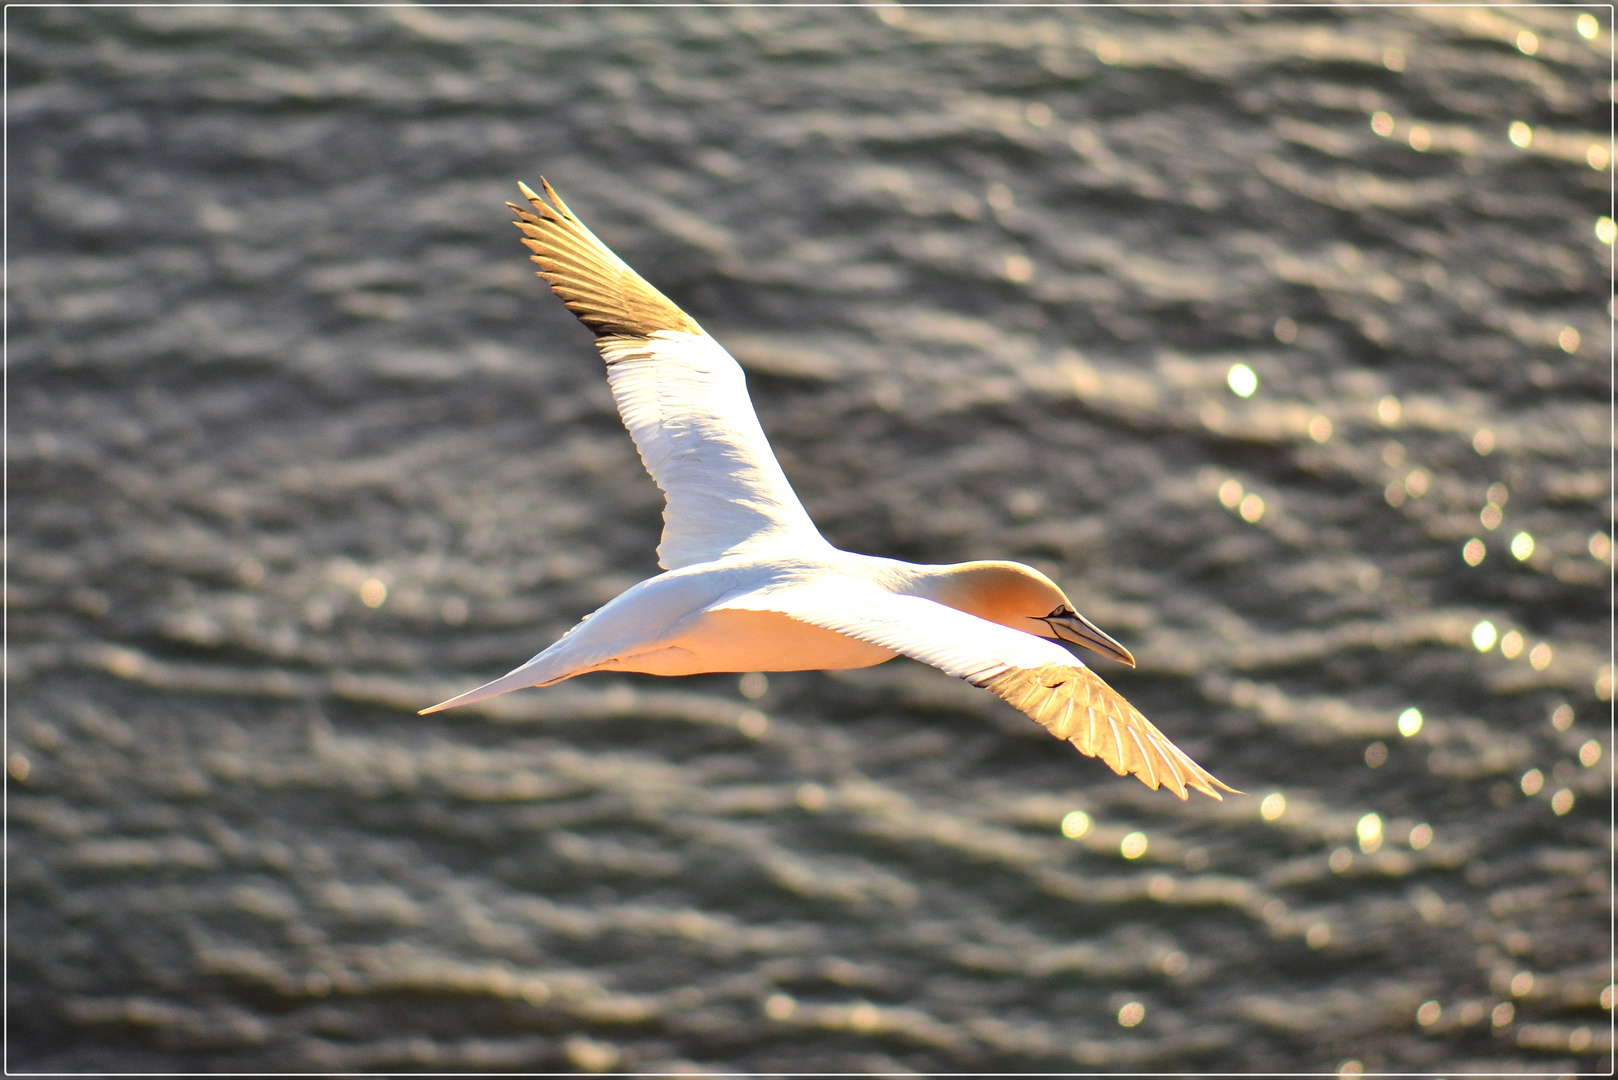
top-left (6, 6), bottom-right (1612, 1072)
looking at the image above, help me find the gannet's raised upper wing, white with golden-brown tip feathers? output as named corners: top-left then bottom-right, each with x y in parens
top-left (506, 180), bottom-right (825, 570)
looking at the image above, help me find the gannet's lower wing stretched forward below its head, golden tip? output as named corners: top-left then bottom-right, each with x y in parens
top-left (722, 583), bottom-right (1239, 798)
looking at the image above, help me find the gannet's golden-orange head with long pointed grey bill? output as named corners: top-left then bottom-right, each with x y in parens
top-left (930, 562), bottom-right (1134, 667)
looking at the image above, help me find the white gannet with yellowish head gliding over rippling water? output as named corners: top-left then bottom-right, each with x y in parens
top-left (422, 178), bottom-right (1236, 798)
